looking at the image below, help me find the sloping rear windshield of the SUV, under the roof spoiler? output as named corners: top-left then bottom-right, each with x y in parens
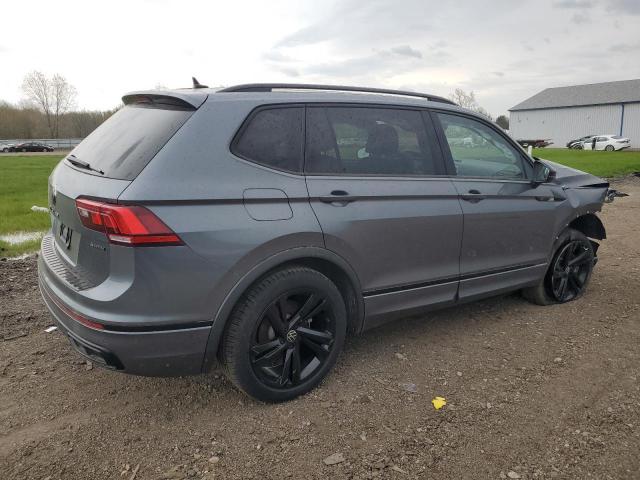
top-left (72, 105), bottom-right (194, 180)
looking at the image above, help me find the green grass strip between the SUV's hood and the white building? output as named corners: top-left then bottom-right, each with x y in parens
top-left (533, 148), bottom-right (640, 178)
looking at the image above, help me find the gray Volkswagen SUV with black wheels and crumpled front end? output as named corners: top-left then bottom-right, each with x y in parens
top-left (39, 84), bottom-right (608, 401)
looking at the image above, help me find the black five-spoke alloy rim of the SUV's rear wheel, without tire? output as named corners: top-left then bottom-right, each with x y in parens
top-left (251, 289), bottom-right (336, 388)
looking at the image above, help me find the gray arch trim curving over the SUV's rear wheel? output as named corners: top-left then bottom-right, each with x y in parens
top-left (202, 247), bottom-right (364, 372)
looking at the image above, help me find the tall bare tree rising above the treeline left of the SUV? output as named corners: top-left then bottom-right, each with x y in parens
top-left (22, 71), bottom-right (77, 138)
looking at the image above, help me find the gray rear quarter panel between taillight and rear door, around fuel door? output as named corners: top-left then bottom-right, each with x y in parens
top-left (118, 99), bottom-right (324, 336)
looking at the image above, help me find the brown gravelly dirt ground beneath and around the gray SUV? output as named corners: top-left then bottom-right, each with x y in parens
top-left (0, 178), bottom-right (640, 480)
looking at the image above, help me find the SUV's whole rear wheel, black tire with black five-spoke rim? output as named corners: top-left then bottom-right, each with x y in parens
top-left (222, 266), bottom-right (347, 402)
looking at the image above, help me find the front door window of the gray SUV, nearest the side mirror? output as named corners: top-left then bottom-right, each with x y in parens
top-left (438, 113), bottom-right (526, 178)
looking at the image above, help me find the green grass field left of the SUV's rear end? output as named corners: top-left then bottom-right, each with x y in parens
top-left (0, 155), bottom-right (61, 257)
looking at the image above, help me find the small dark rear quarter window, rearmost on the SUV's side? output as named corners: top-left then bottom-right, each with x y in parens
top-left (233, 107), bottom-right (304, 172)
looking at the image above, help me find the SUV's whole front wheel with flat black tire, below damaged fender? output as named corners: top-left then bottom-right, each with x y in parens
top-left (522, 228), bottom-right (595, 305)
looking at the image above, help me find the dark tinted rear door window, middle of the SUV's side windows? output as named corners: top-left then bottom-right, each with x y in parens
top-left (305, 107), bottom-right (437, 175)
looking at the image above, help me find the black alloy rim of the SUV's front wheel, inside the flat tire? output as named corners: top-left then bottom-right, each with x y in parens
top-left (550, 239), bottom-right (593, 303)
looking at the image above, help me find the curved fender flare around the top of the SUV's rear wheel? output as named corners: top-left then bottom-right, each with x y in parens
top-left (201, 247), bottom-right (364, 373)
